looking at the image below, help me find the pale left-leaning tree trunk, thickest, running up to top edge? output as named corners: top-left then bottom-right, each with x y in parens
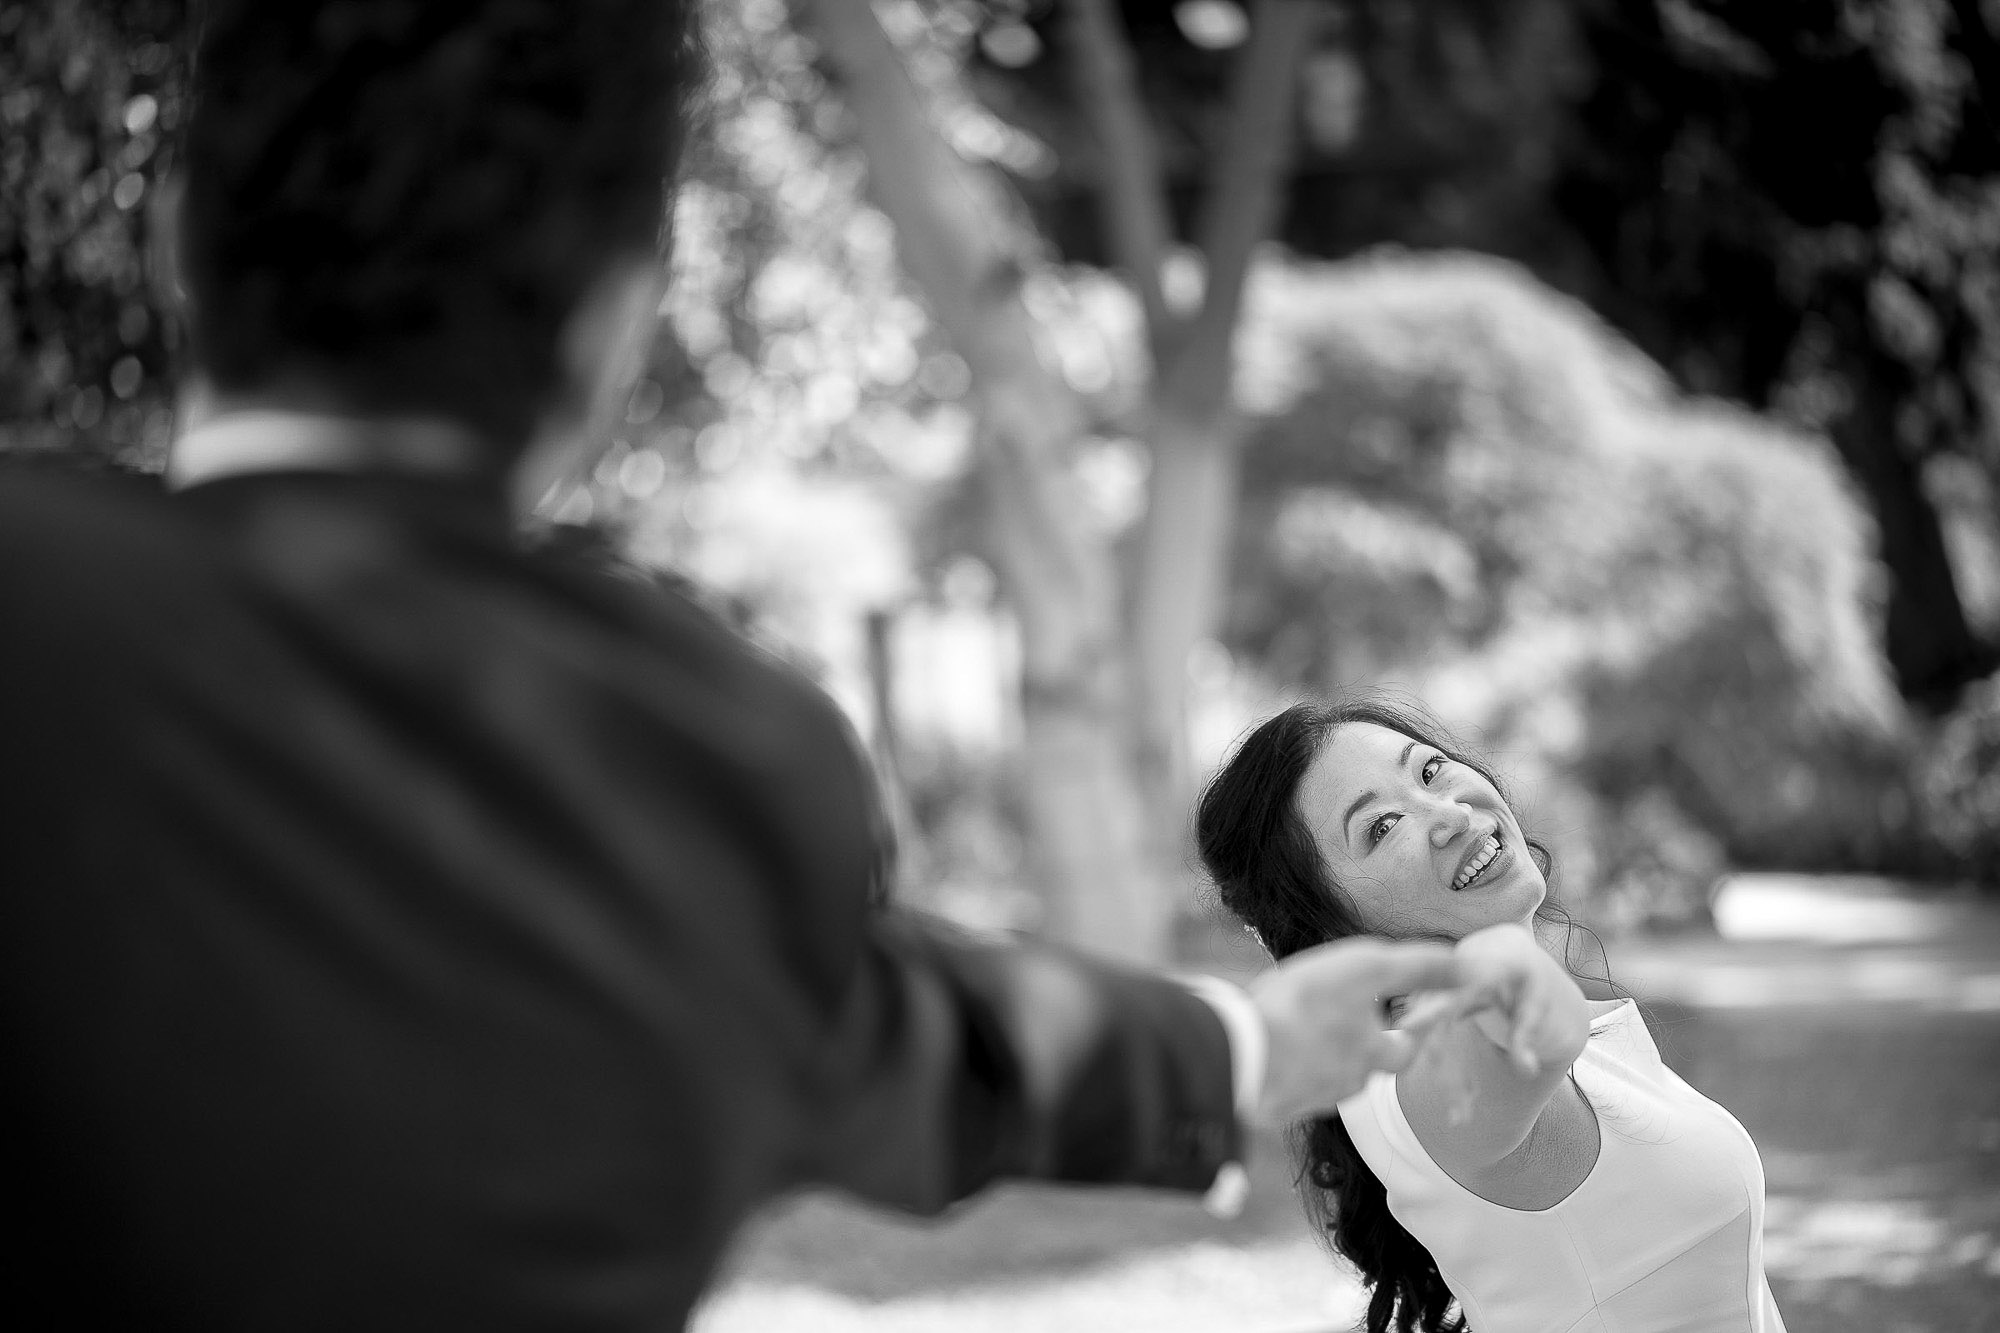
top-left (802, 0), bottom-right (1170, 961)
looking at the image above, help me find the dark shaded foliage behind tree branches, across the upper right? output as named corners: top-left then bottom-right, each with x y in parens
top-left (960, 0), bottom-right (2000, 705)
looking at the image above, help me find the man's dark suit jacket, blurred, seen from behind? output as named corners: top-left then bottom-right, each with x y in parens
top-left (0, 462), bottom-right (1238, 1333)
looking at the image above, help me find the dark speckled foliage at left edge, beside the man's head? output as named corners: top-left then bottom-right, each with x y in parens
top-left (0, 0), bottom-right (186, 462)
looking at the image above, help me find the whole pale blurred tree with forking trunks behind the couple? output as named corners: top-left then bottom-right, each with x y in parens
top-left (800, 0), bottom-right (1320, 961)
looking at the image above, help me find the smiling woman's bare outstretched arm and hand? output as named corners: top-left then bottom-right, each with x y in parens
top-left (1396, 925), bottom-right (1590, 1181)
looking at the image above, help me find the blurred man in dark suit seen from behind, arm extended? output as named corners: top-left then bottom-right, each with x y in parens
top-left (0, 0), bottom-right (1454, 1331)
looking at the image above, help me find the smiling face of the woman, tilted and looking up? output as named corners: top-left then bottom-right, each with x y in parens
top-left (1298, 723), bottom-right (1548, 939)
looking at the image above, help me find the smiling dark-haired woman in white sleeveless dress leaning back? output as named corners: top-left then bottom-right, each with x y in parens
top-left (1196, 701), bottom-right (1784, 1333)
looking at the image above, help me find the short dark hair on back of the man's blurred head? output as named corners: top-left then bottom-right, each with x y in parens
top-left (184, 0), bottom-right (700, 454)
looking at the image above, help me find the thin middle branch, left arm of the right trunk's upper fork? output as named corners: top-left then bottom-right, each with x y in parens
top-left (1062, 0), bottom-right (1174, 352)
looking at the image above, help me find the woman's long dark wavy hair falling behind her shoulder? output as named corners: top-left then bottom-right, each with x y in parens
top-left (1194, 697), bottom-right (1580, 1333)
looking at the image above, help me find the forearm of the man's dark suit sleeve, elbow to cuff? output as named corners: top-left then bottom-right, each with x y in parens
top-left (814, 911), bottom-right (1240, 1213)
